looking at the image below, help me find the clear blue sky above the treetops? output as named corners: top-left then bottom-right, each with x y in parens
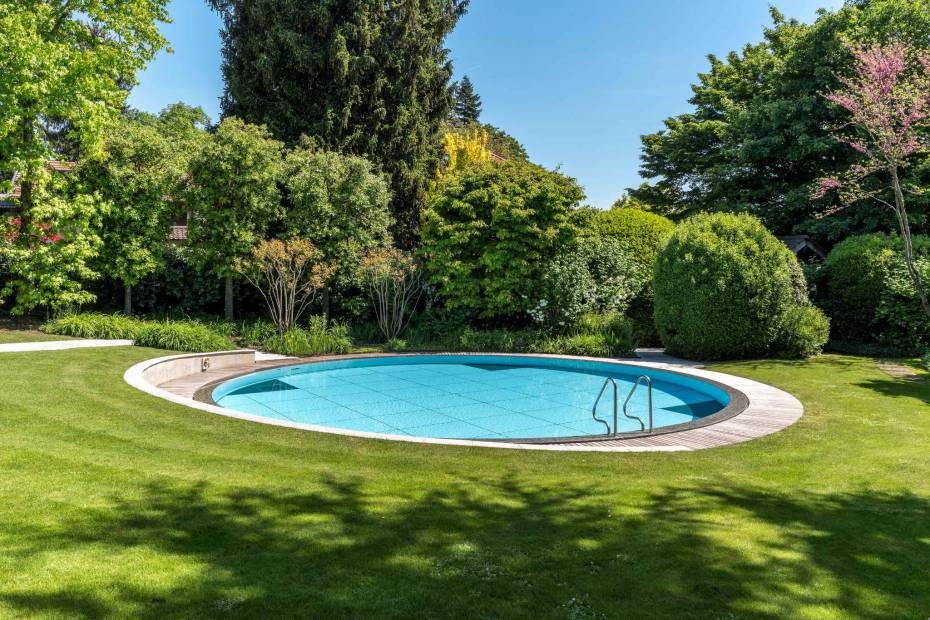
top-left (130, 0), bottom-right (842, 208)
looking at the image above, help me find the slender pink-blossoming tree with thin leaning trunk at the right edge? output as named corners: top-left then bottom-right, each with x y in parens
top-left (813, 44), bottom-right (930, 316)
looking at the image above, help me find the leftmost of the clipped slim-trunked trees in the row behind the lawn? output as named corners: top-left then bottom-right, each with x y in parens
top-left (79, 103), bottom-right (209, 314)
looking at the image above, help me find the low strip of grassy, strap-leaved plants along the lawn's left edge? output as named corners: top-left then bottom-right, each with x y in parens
top-left (43, 313), bottom-right (236, 353)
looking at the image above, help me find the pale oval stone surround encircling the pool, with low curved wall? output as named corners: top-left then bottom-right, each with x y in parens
top-left (124, 349), bottom-right (804, 452)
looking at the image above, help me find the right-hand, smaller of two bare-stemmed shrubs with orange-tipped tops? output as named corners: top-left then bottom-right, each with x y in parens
top-left (362, 248), bottom-right (423, 341)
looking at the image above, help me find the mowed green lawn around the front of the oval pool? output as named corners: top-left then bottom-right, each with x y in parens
top-left (0, 347), bottom-right (930, 619)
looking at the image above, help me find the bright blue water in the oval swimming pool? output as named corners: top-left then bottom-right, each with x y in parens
top-left (212, 355), bottom-right (729, 439)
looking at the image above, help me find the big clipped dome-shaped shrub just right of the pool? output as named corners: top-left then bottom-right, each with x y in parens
top-left (654, 213), bottom-right (825, 359)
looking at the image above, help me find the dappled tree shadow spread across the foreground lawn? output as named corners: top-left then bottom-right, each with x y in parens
top-left (0, 476), bottom-right (930, 618)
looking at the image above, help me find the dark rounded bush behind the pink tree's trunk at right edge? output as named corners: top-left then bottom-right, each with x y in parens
top-left (819, 233), bottom-right (930, 355)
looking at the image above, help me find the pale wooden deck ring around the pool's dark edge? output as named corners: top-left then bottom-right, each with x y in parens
top-left (132, 353), bottom-right (804, 452)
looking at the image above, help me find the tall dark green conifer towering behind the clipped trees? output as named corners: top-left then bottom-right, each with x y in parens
top-left (210, 0), bottom-right (467, 245)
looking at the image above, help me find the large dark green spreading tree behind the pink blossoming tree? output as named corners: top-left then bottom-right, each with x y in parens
top-left (631, 0), bottom-right (930, 243)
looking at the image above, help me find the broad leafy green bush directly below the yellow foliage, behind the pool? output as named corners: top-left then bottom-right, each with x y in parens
top-left (422, 162), bottom-right (584, 320)
